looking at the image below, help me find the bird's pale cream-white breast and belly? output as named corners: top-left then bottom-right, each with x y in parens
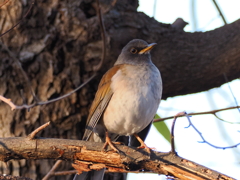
top-left (103, 64), bottom-right (162, 136)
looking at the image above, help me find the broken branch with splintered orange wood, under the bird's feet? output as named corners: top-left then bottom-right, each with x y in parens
top-left (0, 137), bottom-right (233, 180)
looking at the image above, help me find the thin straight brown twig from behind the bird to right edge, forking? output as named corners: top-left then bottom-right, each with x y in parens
top-left (154, 106), bottom-right (240, 124)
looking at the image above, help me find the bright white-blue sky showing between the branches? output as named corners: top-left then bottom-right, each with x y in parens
top-left (128, 0), bottom-right (240, 180)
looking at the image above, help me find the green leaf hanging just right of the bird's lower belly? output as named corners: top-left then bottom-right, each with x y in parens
top-left (153, 114), bottom-right (171, 143)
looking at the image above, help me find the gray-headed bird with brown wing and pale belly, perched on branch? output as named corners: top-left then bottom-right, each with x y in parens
top-left (74, 39), bottom-right (162, 180)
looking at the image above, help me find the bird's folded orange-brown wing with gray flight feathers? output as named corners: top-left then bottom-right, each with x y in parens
top-left (82, 65), bottom-right (122, 141)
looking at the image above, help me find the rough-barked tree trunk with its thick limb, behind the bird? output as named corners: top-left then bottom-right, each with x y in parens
top-left (0, 0), bottom-right (240, 179)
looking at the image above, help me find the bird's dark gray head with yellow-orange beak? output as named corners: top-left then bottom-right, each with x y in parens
top-left (114, 39), bottom-right (156, 65)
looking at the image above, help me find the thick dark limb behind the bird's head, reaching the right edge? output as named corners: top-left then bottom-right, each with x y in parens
top-left (104, 7), bottom-right (240, 99)
